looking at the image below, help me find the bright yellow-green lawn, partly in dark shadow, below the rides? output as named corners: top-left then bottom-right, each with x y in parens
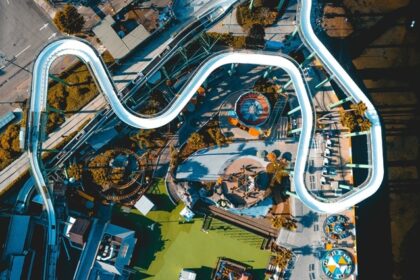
top-left (112, 182), bottom-right (270, 279)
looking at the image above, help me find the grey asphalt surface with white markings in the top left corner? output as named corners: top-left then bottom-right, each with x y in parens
top-left (0, 0), bottom-right (59, 114)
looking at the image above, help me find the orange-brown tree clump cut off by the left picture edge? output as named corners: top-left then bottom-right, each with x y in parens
top-left (0, 124), bottom-right (21, 170)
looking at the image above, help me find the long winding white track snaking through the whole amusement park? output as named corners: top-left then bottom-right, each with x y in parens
top-left (28, 0), bottom-right (384, 254)
